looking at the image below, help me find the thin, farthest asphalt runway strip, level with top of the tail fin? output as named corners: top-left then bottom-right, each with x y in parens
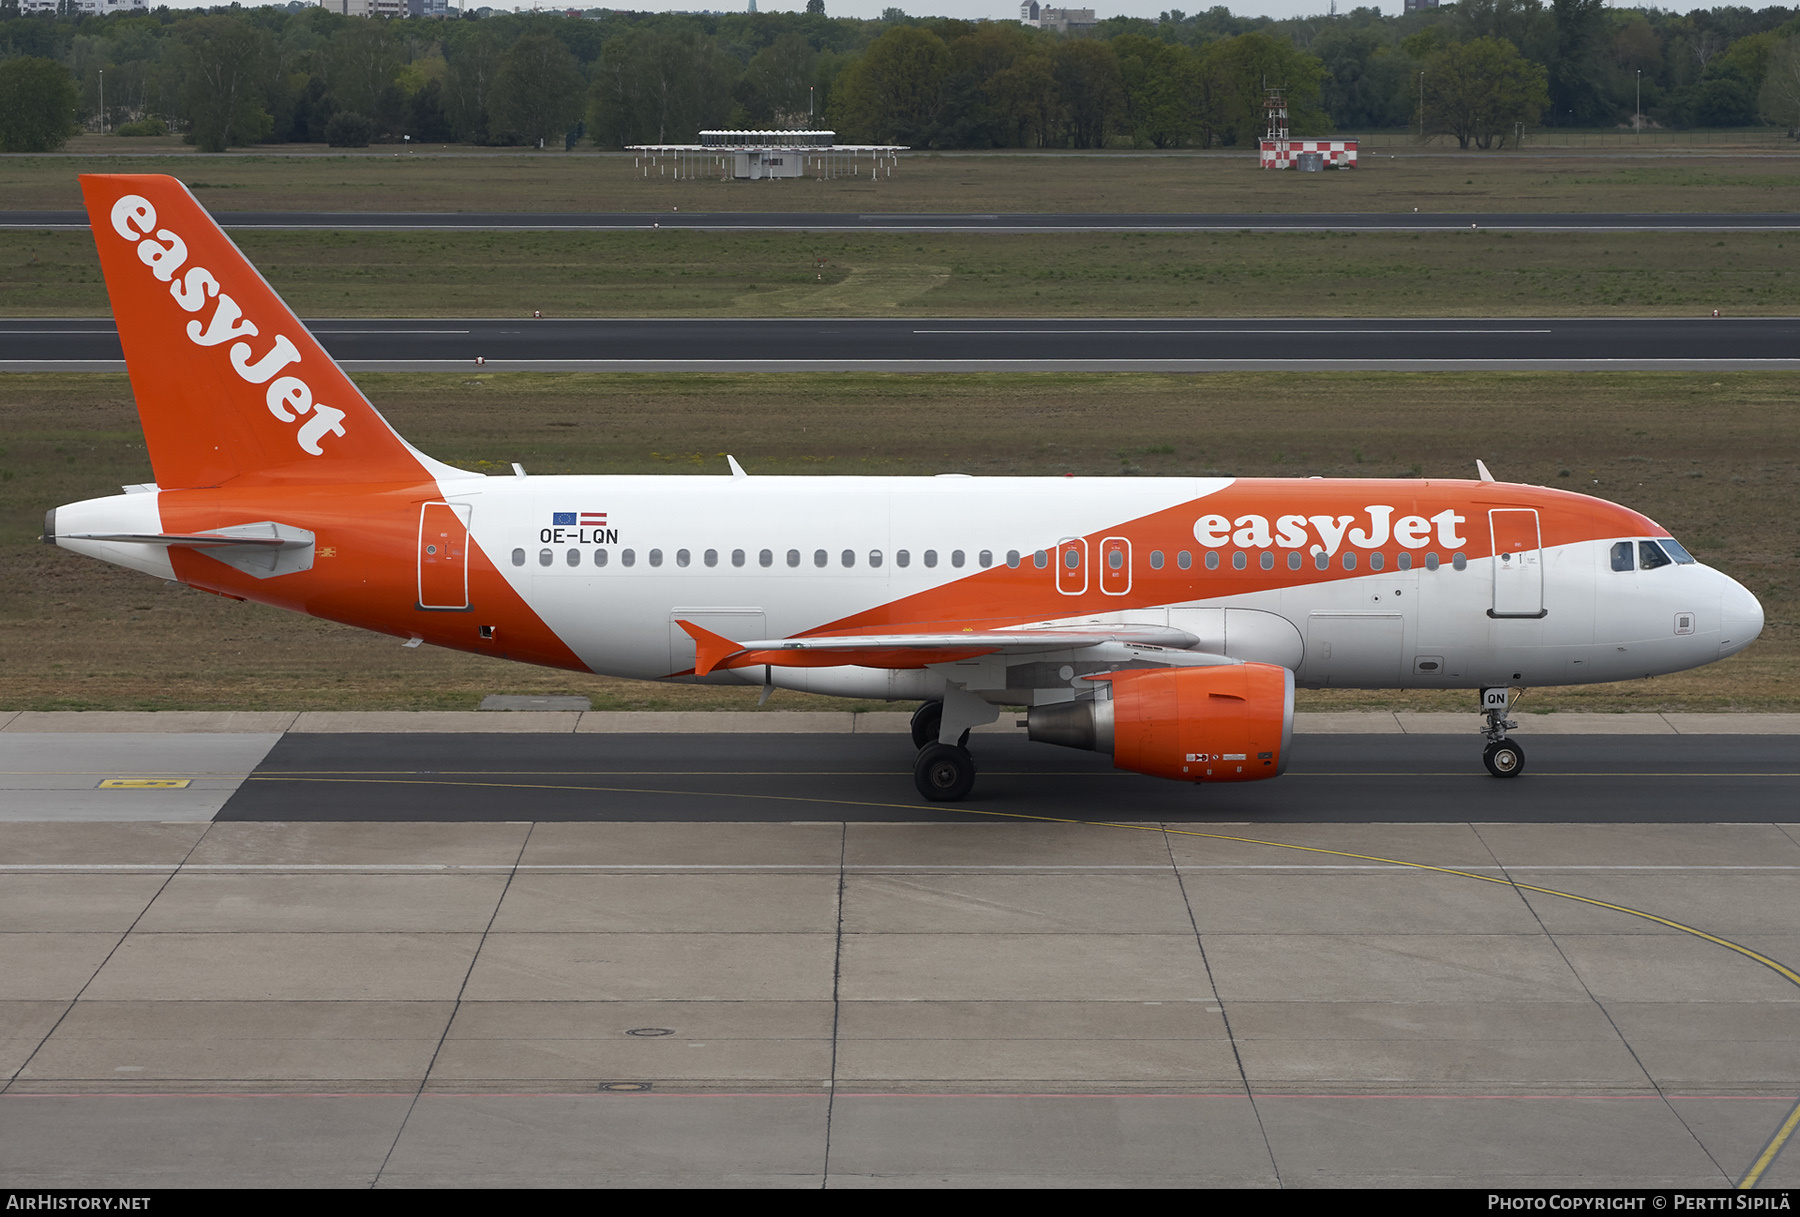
top-left (0, 211), bottom-right (1800, 232)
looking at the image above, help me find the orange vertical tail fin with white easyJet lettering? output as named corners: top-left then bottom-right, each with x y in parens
top-left (81, 175), bottom-right (468, 490)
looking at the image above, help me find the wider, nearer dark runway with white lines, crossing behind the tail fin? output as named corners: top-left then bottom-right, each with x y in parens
top-left (0, 317), bottom-right (1800, 371)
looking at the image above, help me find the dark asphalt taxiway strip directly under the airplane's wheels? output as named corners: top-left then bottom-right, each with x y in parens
top-left (218, 733), bottom-right (1800, 825)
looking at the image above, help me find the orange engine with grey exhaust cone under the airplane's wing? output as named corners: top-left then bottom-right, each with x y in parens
top-left (1026, 663), bottom-right (1294, 781)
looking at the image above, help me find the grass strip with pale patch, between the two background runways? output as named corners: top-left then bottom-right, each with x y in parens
top-left (0, 225), bottom-right (1800, 317)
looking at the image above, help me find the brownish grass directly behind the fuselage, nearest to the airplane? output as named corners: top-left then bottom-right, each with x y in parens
top-left (0, 373), bottom-right (1800, 709)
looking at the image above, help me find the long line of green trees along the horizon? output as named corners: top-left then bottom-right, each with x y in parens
top-left (0, 0), bottom-right (1800, 151)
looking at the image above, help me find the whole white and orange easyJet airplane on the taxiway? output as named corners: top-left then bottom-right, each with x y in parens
top-left (45, 176), bottom-right (1762, 801)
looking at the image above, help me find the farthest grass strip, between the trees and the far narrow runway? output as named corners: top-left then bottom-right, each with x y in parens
top-left (14, 131), bottom-right (1800, 212)
